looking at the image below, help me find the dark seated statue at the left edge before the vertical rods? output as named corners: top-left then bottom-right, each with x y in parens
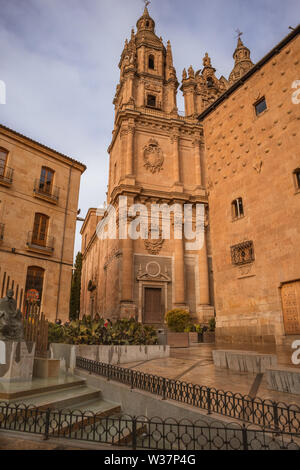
top-left (0, 289), bottom-right (24, 341)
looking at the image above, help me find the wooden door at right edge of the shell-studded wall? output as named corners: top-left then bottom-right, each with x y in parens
top-left (281, 281), bottom-right (300, 335)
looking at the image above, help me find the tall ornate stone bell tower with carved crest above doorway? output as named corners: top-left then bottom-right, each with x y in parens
top-left (85, 7), bottom-right (213, 325)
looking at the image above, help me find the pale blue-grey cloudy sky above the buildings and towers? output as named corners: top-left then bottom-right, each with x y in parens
top-left (0, 0), bottom-right (300, 254)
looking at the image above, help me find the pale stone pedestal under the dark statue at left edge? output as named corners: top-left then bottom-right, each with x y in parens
top-left (0, 341), bottom-right (35, 382)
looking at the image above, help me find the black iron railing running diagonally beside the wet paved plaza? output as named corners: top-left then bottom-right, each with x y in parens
top-left (76, 357), bottom-right (300, 433)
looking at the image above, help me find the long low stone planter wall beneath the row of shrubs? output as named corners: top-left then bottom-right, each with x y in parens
top-left (50, 343), bottom-right (170, 373)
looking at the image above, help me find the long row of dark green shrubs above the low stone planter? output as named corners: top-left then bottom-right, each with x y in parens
top-left (49, 317), bottom-right (157, 345)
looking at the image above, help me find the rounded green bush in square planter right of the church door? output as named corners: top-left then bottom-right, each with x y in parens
top-left (166, 309), bottom-right (191, 348)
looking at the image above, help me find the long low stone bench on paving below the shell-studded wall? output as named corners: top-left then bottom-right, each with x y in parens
top-left (213, 349), bottom-right (277, 374)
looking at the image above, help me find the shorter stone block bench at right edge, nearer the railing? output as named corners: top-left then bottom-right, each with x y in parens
top-left (266, 367), bottom-right (300, 395)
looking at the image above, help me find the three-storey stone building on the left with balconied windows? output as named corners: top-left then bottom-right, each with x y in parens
top-left (0, 125), bottom-right (86, 321)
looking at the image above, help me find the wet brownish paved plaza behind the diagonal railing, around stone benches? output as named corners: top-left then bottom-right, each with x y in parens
top-left (122, 344), bottom-right (300, 405)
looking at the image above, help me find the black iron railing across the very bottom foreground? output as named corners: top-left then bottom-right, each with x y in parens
top-left (0, 403), bottom-right (300, 451)
